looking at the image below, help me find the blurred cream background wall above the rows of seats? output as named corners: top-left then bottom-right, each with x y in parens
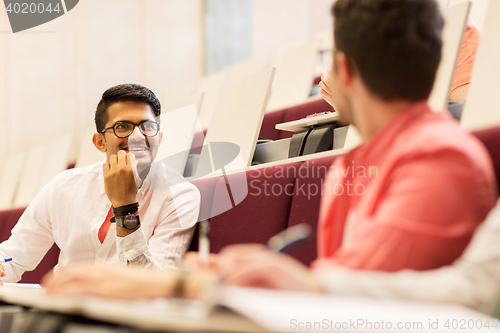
top-left (0, 0), bottom-right (484, 159)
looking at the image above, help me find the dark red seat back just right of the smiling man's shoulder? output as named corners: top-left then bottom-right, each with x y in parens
top-left (206, 162), bottom-right (300, 253)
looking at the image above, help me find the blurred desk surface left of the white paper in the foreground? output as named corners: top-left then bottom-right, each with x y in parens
top-left (0, 287), bottom-right (268, 332)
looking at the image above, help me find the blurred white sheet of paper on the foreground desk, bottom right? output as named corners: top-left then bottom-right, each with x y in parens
top-left (221, 287), bottom-right (500, 333)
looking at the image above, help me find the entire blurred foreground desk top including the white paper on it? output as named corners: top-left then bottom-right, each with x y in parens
top-left (0, 287), bottom-right (500, 333)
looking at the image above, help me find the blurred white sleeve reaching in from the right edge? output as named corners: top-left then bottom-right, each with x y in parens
top-left (316, 200), bottom-right (500, 314)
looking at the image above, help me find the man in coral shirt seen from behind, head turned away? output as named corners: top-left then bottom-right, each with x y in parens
top-left (216, 0), bottom-right (497, 280)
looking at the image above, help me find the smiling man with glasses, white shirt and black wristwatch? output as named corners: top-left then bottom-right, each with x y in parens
top-left (0, 84), bottom-right (200, 282)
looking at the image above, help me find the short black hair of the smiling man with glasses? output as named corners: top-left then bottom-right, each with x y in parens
top-left (94, 84), bottom-right (161, 133)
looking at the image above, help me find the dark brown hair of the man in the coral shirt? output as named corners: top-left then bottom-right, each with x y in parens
top-left (332, 0), bottom-right (444, 101)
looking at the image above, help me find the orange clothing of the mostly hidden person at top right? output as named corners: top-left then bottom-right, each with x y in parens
top-left (451, 15), bottom-right (481, 91)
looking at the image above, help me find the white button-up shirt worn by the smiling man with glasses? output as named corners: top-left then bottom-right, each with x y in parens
top-left (0, 162), bottom-right (200, 282)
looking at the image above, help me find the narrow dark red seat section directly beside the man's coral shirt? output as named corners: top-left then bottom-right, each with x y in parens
top-left (287, 156), bottom-right (336, 265)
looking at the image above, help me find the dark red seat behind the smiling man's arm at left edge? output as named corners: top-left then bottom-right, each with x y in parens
top-left (0, 208), bottom-right (60, 283)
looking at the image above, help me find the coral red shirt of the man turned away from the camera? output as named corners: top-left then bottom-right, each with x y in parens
top-left (313, 102), bottom-right (497, 271)
